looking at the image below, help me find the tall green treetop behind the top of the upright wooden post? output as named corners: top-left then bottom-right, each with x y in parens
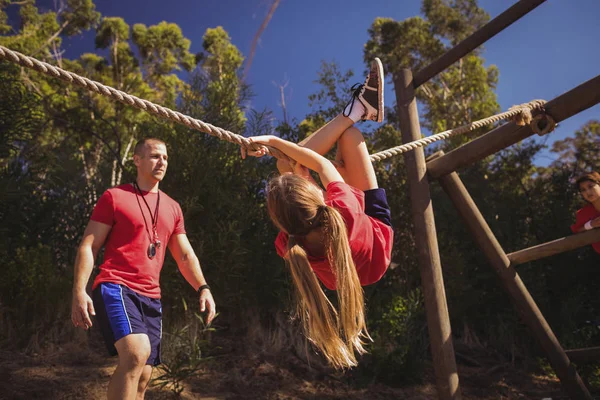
top-left (365, 0), bottom-right (499, 147)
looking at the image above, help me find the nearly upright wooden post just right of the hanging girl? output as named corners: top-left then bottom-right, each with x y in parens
top-left (394, 69), bottom-right (461, 400)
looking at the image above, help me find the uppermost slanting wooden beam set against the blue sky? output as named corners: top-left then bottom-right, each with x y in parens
top-left (414, 0), bottom-right (546, 88)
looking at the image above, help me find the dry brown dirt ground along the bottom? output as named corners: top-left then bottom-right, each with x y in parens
top-left (0, 343), bottom-right (567, 400)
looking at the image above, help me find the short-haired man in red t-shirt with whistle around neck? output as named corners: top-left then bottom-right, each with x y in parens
top-left (71, 138), bottom-right (216, 399)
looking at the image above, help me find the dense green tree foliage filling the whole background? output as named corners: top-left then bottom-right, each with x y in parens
top-left (0, 0), bottom-right (600, 383)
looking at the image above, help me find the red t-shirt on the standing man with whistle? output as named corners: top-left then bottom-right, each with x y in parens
top-left (90, 183), bottom-right (185, 299)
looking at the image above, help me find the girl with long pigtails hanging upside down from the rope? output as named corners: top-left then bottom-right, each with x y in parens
top-left (242, 59), bottom-right (394, 368)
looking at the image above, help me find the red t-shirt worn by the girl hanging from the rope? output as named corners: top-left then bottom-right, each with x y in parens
top-left (275, 182), bottom-right (394, 290)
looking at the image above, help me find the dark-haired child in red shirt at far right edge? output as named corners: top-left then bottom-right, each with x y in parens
top-left (571, 172), bottom-right (600, 253)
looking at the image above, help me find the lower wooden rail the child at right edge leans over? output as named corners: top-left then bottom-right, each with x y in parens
top-left (508, 229), bottom-right (600, 265)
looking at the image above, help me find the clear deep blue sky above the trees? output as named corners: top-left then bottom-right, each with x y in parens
top-left (34, 0), bottom-right (600, 165)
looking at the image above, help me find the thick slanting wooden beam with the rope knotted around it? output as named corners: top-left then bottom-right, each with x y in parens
top-left (427, 75), bottom-right (600, 178)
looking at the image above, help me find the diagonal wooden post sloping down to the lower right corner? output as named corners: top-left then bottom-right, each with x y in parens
top-left (432, 162), bottom-right (592, 399)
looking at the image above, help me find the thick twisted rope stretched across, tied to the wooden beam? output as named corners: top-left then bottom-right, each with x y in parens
top-left (0, 46), bottom-right (555, 162)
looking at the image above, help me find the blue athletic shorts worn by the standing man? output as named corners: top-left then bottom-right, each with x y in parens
top-left (92, 283), bottom-right (162, 365)
